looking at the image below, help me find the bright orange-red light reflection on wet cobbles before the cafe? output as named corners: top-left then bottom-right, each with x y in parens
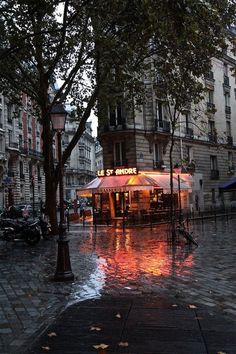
top-left (80, 231), bottom-right (194, 282)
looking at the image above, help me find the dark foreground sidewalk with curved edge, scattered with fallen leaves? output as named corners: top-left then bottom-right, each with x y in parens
top-left (25, 297), bottom-right (236, 354)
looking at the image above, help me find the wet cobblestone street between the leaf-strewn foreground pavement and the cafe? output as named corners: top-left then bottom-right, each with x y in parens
top-left (0, 219), bottom-right (236, 354)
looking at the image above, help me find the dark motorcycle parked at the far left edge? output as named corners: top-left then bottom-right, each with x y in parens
top-left (0, 218), bottom-right (40, 245)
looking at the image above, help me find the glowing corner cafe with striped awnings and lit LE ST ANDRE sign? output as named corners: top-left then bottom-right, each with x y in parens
top-left (77, 168), bottom-right (192, 221)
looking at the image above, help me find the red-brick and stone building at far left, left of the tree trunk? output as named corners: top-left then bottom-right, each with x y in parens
top-left (0, 95), bottom-right (45, 209)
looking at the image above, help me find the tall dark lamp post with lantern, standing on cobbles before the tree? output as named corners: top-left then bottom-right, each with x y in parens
top-left (51, 103), bottom-right (74, 281)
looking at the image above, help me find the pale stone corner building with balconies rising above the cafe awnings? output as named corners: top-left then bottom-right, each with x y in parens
top-left (98, 48), bottom-right (236, 210)
